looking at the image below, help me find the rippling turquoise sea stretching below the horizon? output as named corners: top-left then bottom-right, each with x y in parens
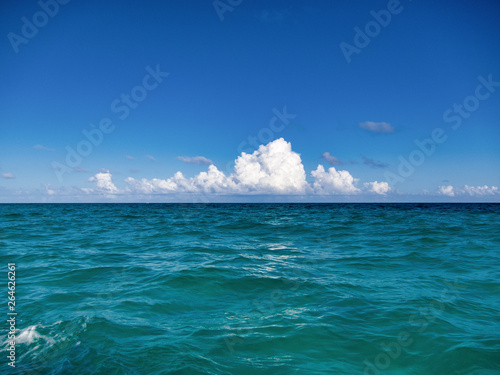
top-left (0, 204), bottom-right (500, 374)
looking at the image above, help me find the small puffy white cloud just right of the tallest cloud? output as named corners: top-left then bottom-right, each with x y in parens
top-left (311, 165), bottom-right (361, 194)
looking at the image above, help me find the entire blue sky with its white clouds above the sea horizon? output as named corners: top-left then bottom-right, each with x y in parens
top-left (0, 0), bottom-right (500, 202)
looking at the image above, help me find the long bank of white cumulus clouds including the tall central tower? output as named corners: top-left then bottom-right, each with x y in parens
top-left (89, 138), bottom-right (390, 195)
